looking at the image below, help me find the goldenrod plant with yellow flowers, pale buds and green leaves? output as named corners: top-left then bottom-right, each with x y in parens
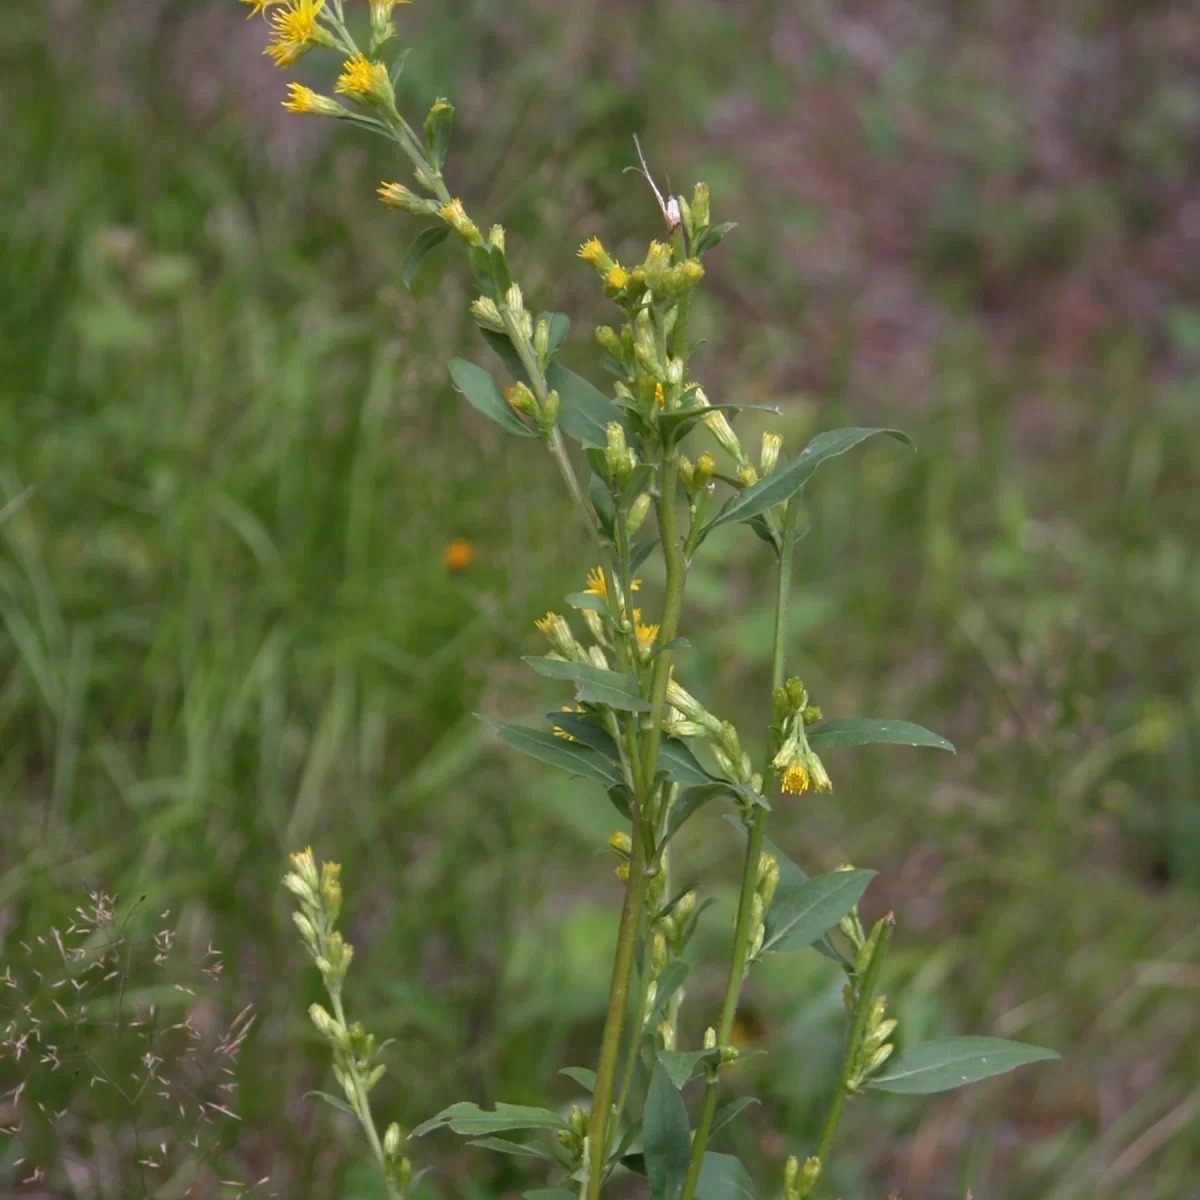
top-left (253, 0), bottom-right (1055, 1200)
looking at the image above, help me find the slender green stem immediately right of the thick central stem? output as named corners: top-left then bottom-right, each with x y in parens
top-left (680, 500), bottom-right (799, 1200)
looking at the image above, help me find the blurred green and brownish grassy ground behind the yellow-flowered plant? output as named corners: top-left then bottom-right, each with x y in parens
top-left (0, 0), bottom-right (1200, 1200)
